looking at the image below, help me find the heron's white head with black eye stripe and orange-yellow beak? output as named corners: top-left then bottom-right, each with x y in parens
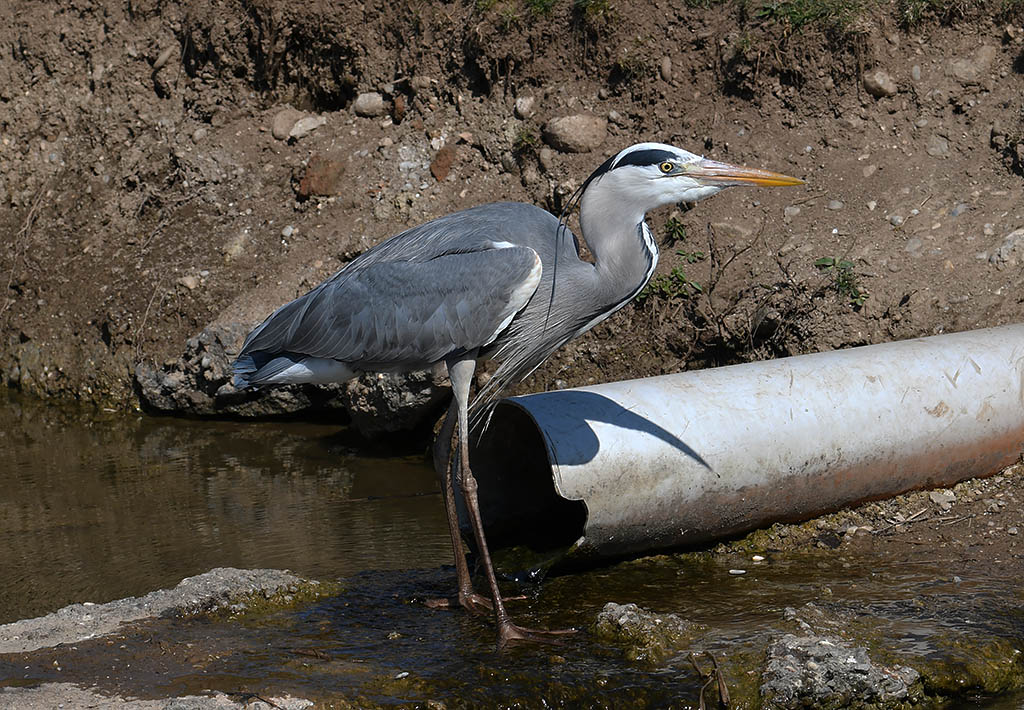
top-left (585, 143), bottom-right (803, 211)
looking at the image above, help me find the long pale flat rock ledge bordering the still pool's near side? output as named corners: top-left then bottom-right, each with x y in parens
top-left (0, 568), bottom-right (305, 651)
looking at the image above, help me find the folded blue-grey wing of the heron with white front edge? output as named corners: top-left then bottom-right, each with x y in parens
top-left (240, 243), bottom-right (541, 369)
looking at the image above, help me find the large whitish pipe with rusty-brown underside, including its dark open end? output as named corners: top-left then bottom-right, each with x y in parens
top-left (473, 325), bottom-right (1024, 563)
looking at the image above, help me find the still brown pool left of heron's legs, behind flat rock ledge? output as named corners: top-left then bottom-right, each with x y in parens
top-left (0, 395), bottom-right (452, 623)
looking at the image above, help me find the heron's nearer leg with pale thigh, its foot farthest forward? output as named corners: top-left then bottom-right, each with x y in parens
top-left (447, 353), bottom-right (575, 649)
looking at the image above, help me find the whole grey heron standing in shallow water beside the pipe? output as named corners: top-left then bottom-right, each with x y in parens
top-left (233, 142), bottom-right (802, 645)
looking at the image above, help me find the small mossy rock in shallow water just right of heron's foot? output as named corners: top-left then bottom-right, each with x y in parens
top-left (594, 601), bottom-right (706, 663)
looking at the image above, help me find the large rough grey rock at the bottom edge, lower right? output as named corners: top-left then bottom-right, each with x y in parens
top-left (761, 634), bottom-right (922, 710)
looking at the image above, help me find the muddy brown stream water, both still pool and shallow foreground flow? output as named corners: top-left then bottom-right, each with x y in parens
top-left (0, 395), bottom-right (1024, 710)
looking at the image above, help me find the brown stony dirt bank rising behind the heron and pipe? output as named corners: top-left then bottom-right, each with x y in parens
top-left (0, 0), bottom-right (1024, 420)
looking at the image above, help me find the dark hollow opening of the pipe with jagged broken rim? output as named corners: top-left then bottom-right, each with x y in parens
top-left (470, 402), bottom-right (587, 551)
